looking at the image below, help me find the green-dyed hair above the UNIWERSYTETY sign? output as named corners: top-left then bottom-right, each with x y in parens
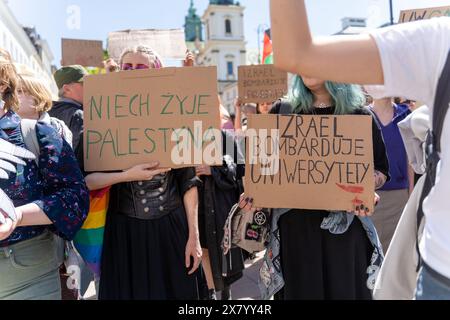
top-left (287, 75), bottom-right (366, 115)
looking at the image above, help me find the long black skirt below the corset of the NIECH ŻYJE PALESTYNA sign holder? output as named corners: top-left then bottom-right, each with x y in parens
top-left (99, 169), bottom-right (204, 300)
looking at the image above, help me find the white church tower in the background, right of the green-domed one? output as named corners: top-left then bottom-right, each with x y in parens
top-left (197, 0), bottom-right (246, 94)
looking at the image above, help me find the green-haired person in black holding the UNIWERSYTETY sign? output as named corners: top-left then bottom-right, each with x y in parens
top-left (240, 76), bottom-right (389, 300)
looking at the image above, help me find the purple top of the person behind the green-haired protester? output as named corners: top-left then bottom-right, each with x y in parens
top-left (371, 104), bottom-right (411, 191)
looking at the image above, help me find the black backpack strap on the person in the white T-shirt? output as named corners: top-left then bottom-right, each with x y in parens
top-left (417, 52), bottom-right (450, 269)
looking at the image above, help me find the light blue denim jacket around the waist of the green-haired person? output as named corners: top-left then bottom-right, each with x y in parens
top-left (258, 209), bottom-right (384, 300)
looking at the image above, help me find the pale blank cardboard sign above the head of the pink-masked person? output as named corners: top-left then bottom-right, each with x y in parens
top-left (108, 29), bottom-right (187, 61)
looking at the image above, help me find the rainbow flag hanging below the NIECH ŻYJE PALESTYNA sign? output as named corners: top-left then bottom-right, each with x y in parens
top-left (73, 187), bottom-right (110, 276)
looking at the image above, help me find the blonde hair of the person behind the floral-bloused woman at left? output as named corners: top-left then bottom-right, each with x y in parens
top-left (17, 65), bottom-right (53, 113)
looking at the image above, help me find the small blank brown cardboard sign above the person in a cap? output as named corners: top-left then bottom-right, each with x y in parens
top-left (61, 39), bottom-right (103, 68)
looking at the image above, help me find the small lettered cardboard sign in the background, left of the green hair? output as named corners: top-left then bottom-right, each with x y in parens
top-left (238, 64), bottom-right (288, 103)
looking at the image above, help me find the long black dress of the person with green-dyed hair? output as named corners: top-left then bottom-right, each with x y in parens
top-left (271, 104), bottom-right (389, 300)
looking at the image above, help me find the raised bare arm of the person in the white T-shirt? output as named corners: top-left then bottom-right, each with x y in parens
top-left (270, 0), bottom-right (384, 84)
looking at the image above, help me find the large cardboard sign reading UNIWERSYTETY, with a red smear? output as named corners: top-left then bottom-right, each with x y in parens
top-left (245, 115), bottom-right (375, 212)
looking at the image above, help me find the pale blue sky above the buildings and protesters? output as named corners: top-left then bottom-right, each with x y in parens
top-left (8, 0), bottom-right (450, 64)
